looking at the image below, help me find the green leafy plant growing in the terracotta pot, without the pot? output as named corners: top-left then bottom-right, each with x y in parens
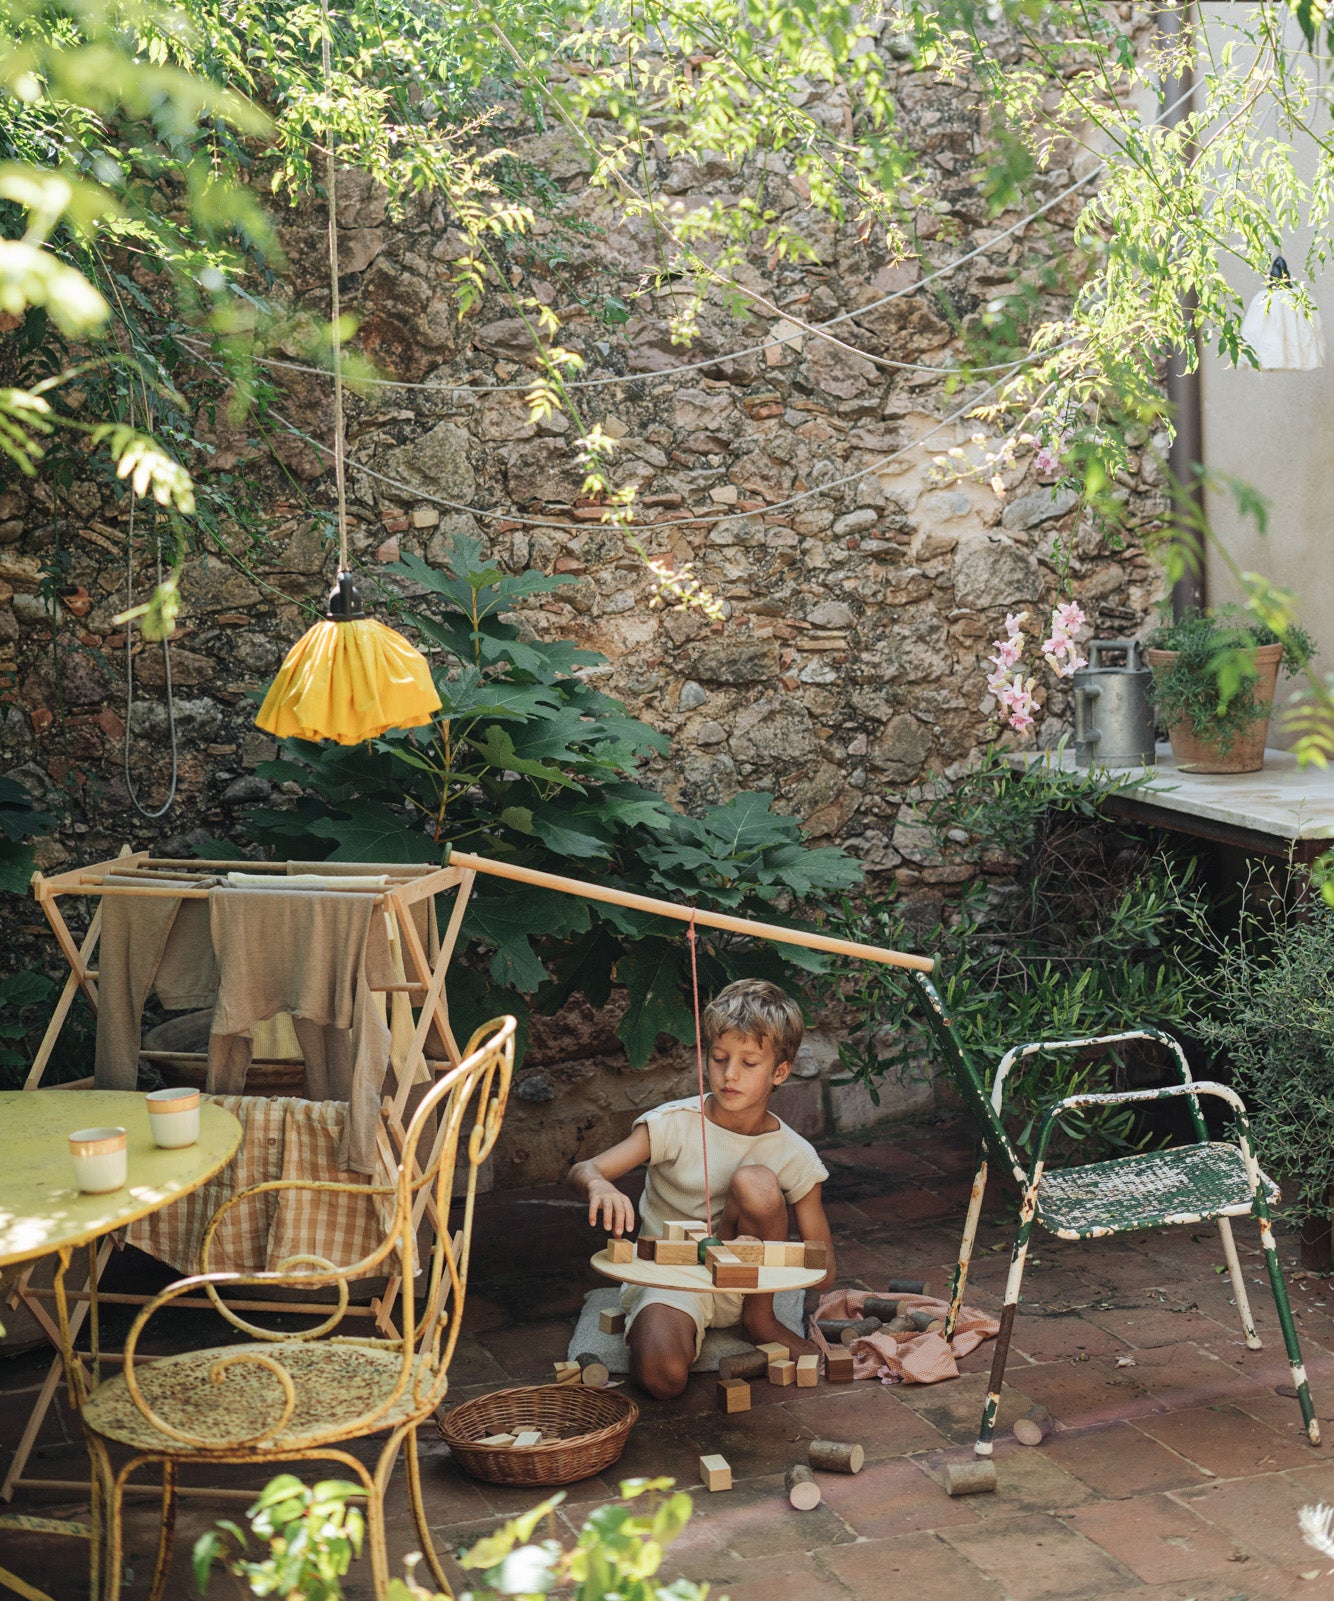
top-left (1147, 607), bottom-right (1315, 754)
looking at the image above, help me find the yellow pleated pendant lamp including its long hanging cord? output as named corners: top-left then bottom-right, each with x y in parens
top-left (255, 8), bottom-right (440, 744)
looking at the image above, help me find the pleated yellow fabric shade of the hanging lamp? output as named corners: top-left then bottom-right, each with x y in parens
top-left (255, 616), bottom-right (440, 744)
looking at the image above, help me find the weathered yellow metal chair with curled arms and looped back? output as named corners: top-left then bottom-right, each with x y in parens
top-left (80, 1017), bottom-right (514, 1601)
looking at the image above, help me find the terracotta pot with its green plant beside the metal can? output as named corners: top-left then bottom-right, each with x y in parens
top-left (1147, 607), bottom-right (1315, 773)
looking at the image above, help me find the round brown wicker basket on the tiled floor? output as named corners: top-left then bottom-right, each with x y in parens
top-left (436, 1385), bottom-right (639, 1484)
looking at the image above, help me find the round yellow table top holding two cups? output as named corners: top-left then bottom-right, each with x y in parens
top-left (0, 1090), bottom-right (240, 1266)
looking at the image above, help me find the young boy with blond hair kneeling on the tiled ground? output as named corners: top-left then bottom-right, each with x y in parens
top-left (570, 978), bottom-right (834, 1401)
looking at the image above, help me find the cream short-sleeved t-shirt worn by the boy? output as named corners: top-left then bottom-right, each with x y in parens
top-left (634, 1097), bottom-right (830, 1236)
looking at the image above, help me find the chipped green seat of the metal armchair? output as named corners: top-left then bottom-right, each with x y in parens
top-left (1038, 1143), bottom-right (1278, 1239)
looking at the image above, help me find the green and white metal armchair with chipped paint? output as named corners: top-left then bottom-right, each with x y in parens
top-left (911, 973), bottom-right (1320, 1457)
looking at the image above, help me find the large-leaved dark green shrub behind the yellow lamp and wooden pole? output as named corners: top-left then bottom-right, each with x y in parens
top-left (247, 538), bottom-right (862, 1066)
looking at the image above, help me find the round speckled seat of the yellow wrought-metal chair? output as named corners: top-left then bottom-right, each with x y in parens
top-left (82, 1340), bottom-right (445, 1459)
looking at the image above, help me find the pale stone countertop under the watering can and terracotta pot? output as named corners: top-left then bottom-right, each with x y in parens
top-left (1020, 744), bottom-right (1334, 839)
